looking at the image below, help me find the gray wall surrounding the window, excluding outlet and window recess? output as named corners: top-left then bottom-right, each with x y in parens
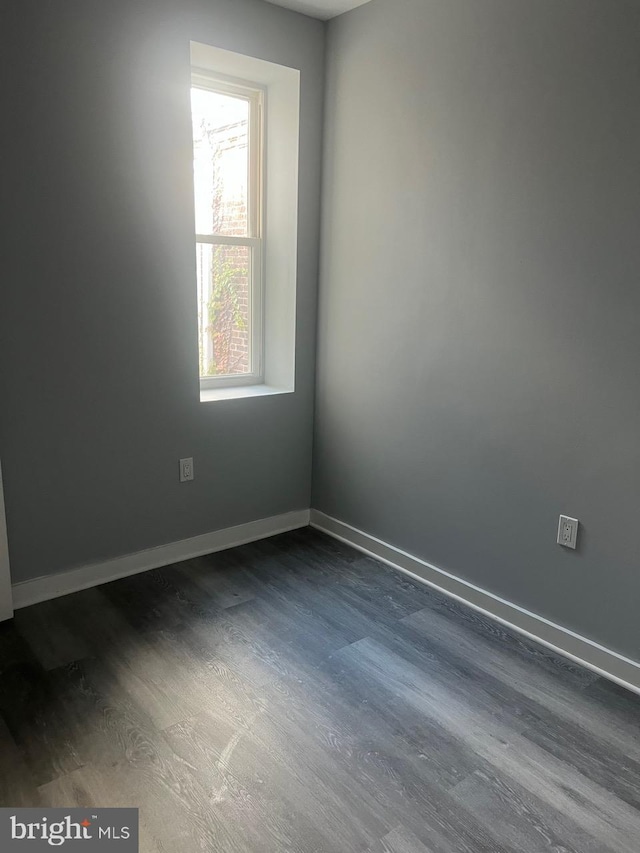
top-left (0, 0), bottom-right (324, 581)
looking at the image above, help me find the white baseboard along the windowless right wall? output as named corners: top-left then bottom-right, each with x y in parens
top-left (311, 509), bottom-right (640, 694)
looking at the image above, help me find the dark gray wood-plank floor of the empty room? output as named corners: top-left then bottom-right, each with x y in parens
top-left (0, 529), bottom-right (640, 853)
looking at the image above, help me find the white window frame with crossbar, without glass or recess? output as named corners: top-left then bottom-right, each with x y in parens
top-left (191, 67), bottom-right (266, 392)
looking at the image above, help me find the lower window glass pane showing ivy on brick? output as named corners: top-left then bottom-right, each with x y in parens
top-left (196, 243), bottom-right (251, 376)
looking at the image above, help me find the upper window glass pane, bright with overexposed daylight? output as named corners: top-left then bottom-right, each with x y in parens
top-left (191, 87), bottom-right (249, 237)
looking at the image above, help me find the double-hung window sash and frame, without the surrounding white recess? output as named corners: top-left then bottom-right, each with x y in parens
top-left (191, 71), bottom-right (264, 389)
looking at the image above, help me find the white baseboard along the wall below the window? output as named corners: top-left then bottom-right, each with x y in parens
top-left (13, 509), bottom-right (309, 610)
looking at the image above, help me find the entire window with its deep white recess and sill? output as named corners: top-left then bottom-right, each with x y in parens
top-left (191, 42), bottom-right (300, 403)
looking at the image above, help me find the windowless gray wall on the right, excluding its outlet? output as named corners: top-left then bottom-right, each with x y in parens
top-left (313, 0), bottom-right (640, 658)
